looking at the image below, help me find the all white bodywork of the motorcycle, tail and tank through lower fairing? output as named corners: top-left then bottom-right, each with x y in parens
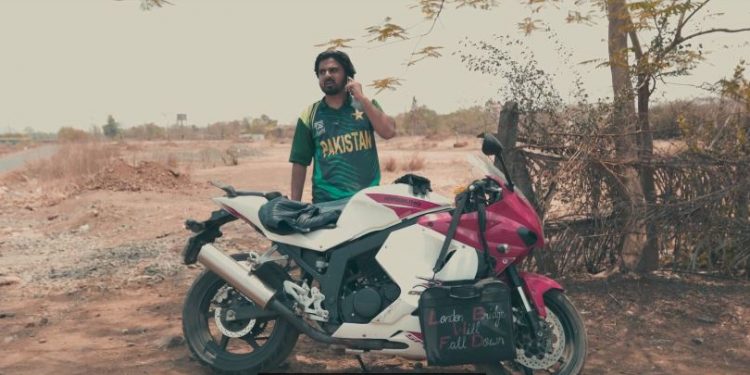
top-left (214, 184), bottom-right (468, 359)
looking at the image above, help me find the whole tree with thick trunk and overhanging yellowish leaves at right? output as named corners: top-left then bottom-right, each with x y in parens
top-left (390, 0), bottom-right (750, 271)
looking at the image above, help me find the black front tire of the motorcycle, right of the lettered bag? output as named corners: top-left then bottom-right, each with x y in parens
top-left (476, 290), bottom-right (588, 375)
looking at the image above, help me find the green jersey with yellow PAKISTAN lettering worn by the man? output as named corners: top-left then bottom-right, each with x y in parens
top-left (289, 96), bottom-right (380, 203)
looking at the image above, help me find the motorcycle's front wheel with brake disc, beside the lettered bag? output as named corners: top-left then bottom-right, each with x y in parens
top-left (477, 290), bottom-right (588, 375)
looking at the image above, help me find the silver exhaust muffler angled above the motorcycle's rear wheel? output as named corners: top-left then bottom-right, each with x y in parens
top-left (198, 244), bottom-right (276, 309)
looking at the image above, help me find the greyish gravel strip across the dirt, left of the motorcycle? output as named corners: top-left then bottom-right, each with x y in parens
top-left (0, 220), bottom-right (185, 295)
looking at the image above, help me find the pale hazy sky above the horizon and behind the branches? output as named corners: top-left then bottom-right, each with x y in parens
top-left (0, 0), bottom-right (750, 132)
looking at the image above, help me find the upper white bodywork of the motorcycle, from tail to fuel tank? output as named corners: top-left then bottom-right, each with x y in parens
top-left (213, 184), bottom-right (451, 251)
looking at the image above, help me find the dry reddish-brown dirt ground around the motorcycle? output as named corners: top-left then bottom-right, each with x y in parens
top-left (0, 138), bottom-right (750, 375)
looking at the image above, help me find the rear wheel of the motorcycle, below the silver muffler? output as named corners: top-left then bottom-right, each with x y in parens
top-left (182, 254), bottom-right (299, 374)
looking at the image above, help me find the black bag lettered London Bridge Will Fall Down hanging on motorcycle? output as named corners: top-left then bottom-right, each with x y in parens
top-left (419, 279), bottom-right (515, 366)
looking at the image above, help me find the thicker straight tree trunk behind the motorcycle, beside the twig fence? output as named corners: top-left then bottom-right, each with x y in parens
top-left (607, 0), bottom-right (646, 271)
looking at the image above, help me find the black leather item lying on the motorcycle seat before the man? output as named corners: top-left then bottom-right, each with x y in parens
top-left (258, 197), bottom-right (341, 235)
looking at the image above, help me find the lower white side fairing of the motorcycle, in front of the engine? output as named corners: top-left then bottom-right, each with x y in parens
top-left (333, 225), bottom-right (479, 359)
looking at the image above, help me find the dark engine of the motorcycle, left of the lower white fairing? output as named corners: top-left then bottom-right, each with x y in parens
top-left (339, 253), bottom-right (401, 323)
